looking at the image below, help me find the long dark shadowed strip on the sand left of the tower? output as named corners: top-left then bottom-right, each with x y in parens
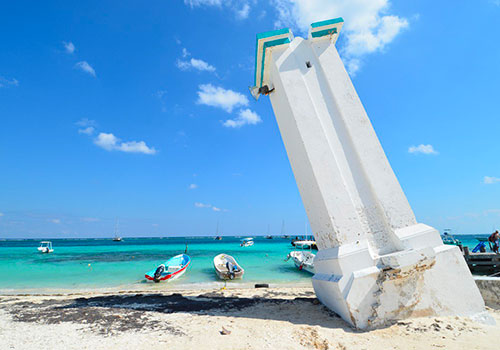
top-left (4, 290), bottom-right (360, 334)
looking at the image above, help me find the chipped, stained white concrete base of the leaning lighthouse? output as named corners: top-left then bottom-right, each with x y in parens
top-left (312, 224), bottom-right (495, 329)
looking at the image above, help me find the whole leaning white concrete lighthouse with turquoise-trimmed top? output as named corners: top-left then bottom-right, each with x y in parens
top-left (251, 18), bottom-right (492, 329)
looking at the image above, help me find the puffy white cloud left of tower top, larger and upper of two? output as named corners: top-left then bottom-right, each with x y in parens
top-left (197, 84), bottom-right (248, 113)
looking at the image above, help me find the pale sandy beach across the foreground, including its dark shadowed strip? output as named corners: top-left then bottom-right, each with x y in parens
top-left (0, 286), bottom-right (500, 350)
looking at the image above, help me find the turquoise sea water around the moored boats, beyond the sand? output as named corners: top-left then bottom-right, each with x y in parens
top-left (0, 235), bottom-right (487, 293)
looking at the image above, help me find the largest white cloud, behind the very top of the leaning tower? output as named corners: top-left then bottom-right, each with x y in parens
top-left (272, 0), bottom-right (409, 74)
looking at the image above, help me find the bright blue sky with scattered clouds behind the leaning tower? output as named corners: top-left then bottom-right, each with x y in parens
top-left (0, 0), bottom-right (500, 238)
